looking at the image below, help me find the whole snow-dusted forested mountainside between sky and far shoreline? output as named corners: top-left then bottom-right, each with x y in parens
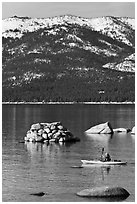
top-left (2, 15), bottom-right (135, 102)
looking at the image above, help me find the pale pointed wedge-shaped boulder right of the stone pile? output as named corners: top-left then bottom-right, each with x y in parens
top-left (85, 122), bottom-right (113, 134)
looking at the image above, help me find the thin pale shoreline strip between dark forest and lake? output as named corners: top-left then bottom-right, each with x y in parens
top-left (2, 101), bottom-right (135, 105)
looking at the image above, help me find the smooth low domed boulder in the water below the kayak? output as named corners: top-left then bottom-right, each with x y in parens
top-left (77, 186), bottom-right (130, 198)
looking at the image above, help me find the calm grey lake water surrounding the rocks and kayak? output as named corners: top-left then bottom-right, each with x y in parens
top-left (2, 104), bottom-right (135, 202)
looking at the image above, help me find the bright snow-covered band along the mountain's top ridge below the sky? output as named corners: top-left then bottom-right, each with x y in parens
top-left (2, 15), bottom-right (135, 46)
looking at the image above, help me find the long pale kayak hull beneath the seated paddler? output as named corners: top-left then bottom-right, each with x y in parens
top-left (81, 160), bottom-right (127, 165)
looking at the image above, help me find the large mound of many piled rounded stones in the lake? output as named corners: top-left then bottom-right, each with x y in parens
top-left (24, 122), bottom-right (79, 142)
